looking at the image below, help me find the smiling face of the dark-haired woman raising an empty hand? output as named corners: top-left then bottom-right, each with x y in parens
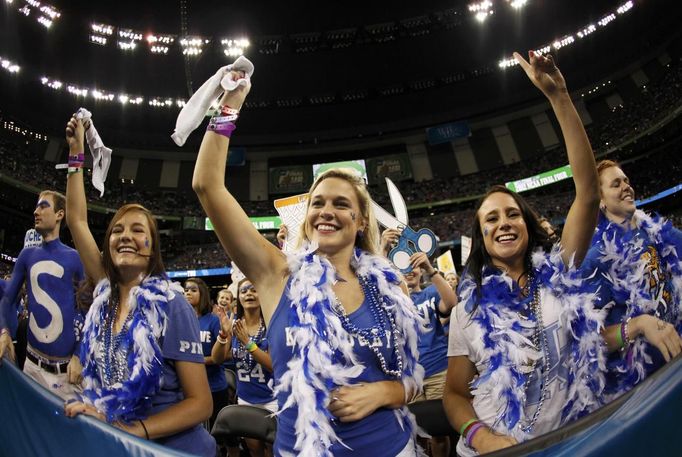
top-left (476, 192), bottom-right (528, 270)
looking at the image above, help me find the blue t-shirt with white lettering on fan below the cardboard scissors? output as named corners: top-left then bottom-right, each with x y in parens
top-left (410, 284), bottom-right (448, 378)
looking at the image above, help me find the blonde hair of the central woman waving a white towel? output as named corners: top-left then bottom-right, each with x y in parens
top-left (297, 168), bottom-right (380, 255)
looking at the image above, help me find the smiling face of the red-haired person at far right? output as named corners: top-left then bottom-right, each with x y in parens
top-left (599, 166), bottom-right (637, 223)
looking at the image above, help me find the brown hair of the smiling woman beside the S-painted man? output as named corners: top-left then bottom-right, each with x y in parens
top-left (102, 203), bottom-right (166, 284)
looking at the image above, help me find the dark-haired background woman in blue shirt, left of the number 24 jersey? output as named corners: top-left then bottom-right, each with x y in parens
top-left (185, 278), bottom-right (232, 431)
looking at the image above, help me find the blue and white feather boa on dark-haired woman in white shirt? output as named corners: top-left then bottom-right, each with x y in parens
top-left (458, 245), bottom-right (605, 442)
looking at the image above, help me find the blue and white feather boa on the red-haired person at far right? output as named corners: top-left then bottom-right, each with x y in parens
top-left (594, 210), bottom-right (682, 397)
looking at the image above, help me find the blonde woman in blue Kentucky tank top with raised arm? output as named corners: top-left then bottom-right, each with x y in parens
top-left (192, 68), bottom-right (423, 457)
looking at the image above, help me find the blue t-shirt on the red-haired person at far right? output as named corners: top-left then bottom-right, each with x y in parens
top-left (582, 221), bottom-right (682, 391)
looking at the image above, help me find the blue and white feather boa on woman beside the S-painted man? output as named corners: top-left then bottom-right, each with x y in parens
top-left (81, 276), bottom-right (182, 422)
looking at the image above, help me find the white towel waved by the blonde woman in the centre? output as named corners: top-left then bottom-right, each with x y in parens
top-left (171, 56), bottom-right (254, 146)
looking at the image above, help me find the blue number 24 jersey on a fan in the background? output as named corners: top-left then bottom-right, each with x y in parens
top-left (232, 336), bottom-right (275, 405)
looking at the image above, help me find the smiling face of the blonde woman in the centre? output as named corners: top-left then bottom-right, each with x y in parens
top-left (305, 178), bottom-right (366, 254)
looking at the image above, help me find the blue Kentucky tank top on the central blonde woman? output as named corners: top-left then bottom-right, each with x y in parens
top-left (267, 279), bottom-right (411, 457)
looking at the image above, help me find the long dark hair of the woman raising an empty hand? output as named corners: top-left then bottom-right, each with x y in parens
top-left (462, 185), bottom-right (552, 309)
